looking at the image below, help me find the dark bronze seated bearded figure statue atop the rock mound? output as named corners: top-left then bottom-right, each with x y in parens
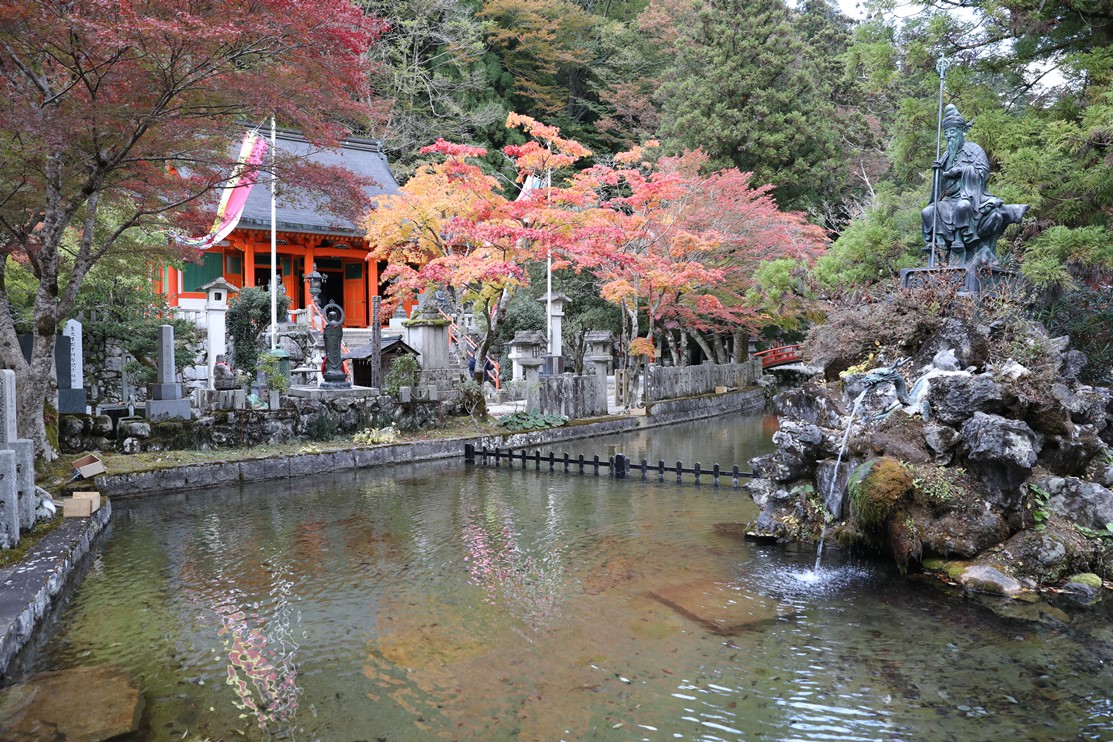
top-left (922, 105), bottom-right (1028, 266)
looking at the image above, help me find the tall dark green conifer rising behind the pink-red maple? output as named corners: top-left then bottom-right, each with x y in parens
top-left (658, 0), bottom-right (844, 209)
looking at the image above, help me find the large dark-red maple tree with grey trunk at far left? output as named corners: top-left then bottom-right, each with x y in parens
top-left (0, 0), bottom-right (382, 458)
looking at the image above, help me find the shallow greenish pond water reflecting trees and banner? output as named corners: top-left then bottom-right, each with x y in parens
top-left (0, 416), bottom-right (1113, 741)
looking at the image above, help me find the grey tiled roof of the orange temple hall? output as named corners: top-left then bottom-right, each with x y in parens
top-left (239, 131), bottom-right (398, 235)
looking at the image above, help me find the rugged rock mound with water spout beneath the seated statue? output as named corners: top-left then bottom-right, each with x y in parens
top-left (749, 301), bottom-right (1113, 594)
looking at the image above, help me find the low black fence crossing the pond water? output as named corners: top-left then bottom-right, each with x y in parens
top-left (464, 443), bottom-right (754, 487)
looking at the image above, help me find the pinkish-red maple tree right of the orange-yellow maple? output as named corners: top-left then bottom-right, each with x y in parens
top-left (556, 141), bottom-right (826, 393)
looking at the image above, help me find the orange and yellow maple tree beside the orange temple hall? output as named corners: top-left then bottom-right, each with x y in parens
top-left (363, 113), bottom-right (590, 379)
